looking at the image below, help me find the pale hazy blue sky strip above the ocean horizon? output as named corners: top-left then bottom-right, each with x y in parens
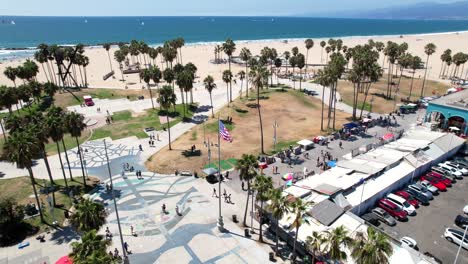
top-left (0, 0), bottom-right (455, 16)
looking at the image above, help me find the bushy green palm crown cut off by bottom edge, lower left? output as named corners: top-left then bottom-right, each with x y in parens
top-left (69, 230), bottom-right (115, 264)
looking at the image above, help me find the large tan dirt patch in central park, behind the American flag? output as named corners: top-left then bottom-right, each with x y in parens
top-left (146, 90), bottom-right (349, 173)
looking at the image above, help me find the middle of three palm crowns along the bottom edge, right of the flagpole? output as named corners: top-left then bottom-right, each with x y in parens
top-left (324, 226), bottom-right (353, 261)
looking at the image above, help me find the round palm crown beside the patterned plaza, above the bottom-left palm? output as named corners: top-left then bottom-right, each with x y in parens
top-left (70, 199), bottom-right (107, 232)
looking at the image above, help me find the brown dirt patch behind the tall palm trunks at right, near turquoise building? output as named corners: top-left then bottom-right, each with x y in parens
top-left (338, 75), bottom-right (449, 114)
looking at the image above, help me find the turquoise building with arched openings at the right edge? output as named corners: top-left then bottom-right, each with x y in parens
top-left (425, 89), bottom-right (468, 135)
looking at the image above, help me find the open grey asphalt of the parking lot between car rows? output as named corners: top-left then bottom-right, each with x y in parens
top-left (380, 173), bottom-right (468, 263)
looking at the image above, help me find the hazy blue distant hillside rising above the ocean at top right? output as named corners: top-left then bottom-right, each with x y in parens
top-left (309, 1), bottom-right (468, 20)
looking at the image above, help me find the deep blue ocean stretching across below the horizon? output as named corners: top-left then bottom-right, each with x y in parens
top-left (0, 16), bottom-right (468, 58)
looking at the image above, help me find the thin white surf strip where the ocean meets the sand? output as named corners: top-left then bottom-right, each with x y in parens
top-left (0, 29), bottom-right (468, 52)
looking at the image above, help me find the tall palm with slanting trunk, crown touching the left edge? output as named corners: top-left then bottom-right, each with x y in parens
top-left (2, 130), bottom-right (45, 223)
